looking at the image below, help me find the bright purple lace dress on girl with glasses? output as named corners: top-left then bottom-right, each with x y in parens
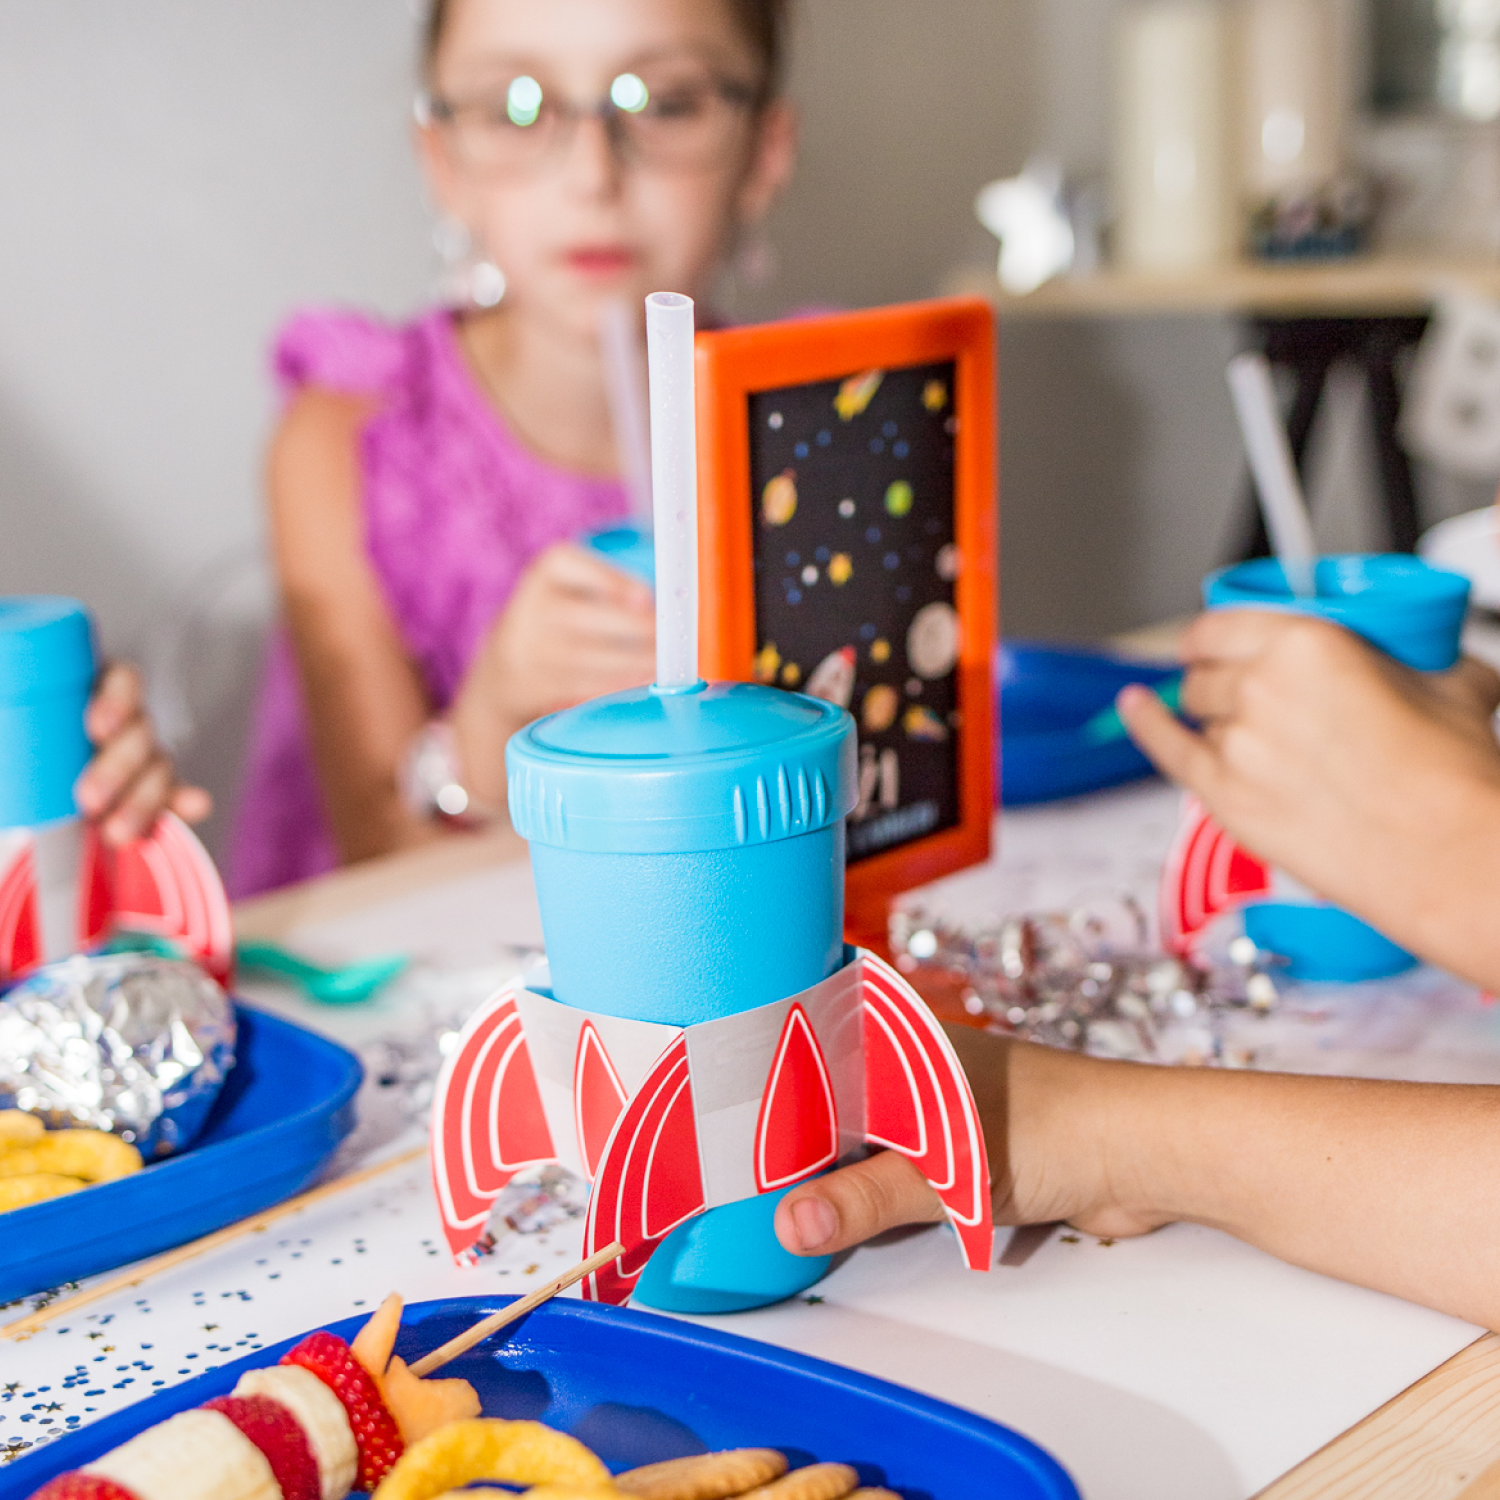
top-left (228, 311), bottom-right (629, 897)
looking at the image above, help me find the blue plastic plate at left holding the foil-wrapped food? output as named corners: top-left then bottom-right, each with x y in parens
top-left (0, 1005), bottom-right (363, 1302)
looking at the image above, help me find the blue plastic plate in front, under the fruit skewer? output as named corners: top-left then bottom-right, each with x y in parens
top-left (0, 1298), bottom-right (1079, 1500)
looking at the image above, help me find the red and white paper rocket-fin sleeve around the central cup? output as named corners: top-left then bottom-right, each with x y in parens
top-left (432, 951), bottom-right (993, 1304)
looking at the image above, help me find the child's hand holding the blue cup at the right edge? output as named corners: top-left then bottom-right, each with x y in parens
top-left (1119, 609), bottom-right (1500, 986)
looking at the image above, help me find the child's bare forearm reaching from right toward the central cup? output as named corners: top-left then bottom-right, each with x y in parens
top-left (1074, 1058), bottom-right (1500, 1328)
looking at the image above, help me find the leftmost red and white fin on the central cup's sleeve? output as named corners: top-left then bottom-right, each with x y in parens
top-left (432, 987), bottom-right (555, 1265)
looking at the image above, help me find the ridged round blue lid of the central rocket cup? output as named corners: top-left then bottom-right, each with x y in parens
top-left (506, 683), bottom-right (858, 854)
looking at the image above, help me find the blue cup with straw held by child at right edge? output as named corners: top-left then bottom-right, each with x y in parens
top-left (1203, 552), bottom-right (1469, 983)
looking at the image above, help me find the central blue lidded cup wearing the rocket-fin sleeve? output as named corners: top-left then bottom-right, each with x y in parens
top-left (506, 683), bottom-right (858, 1313)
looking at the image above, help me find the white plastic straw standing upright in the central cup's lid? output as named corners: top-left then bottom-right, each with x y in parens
top-left (647, 291), bottom-right (698, 689)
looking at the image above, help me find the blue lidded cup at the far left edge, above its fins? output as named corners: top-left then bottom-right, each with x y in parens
top-left (0, 594), bottom-right (96, 828)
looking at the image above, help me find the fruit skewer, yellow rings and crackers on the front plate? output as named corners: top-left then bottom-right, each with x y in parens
top-left (32, 1293), bottom-right (899, 1500)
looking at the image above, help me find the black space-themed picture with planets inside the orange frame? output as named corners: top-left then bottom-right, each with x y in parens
top-left (749, 360), bottom-right (960, 863)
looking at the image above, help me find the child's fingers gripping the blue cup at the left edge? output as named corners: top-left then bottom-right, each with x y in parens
top-left (74, 662), bottom-right (213, 846)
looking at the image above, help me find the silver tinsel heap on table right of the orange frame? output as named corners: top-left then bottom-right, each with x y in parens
top-left (890, 897), bottom-right (1278, 1068)
